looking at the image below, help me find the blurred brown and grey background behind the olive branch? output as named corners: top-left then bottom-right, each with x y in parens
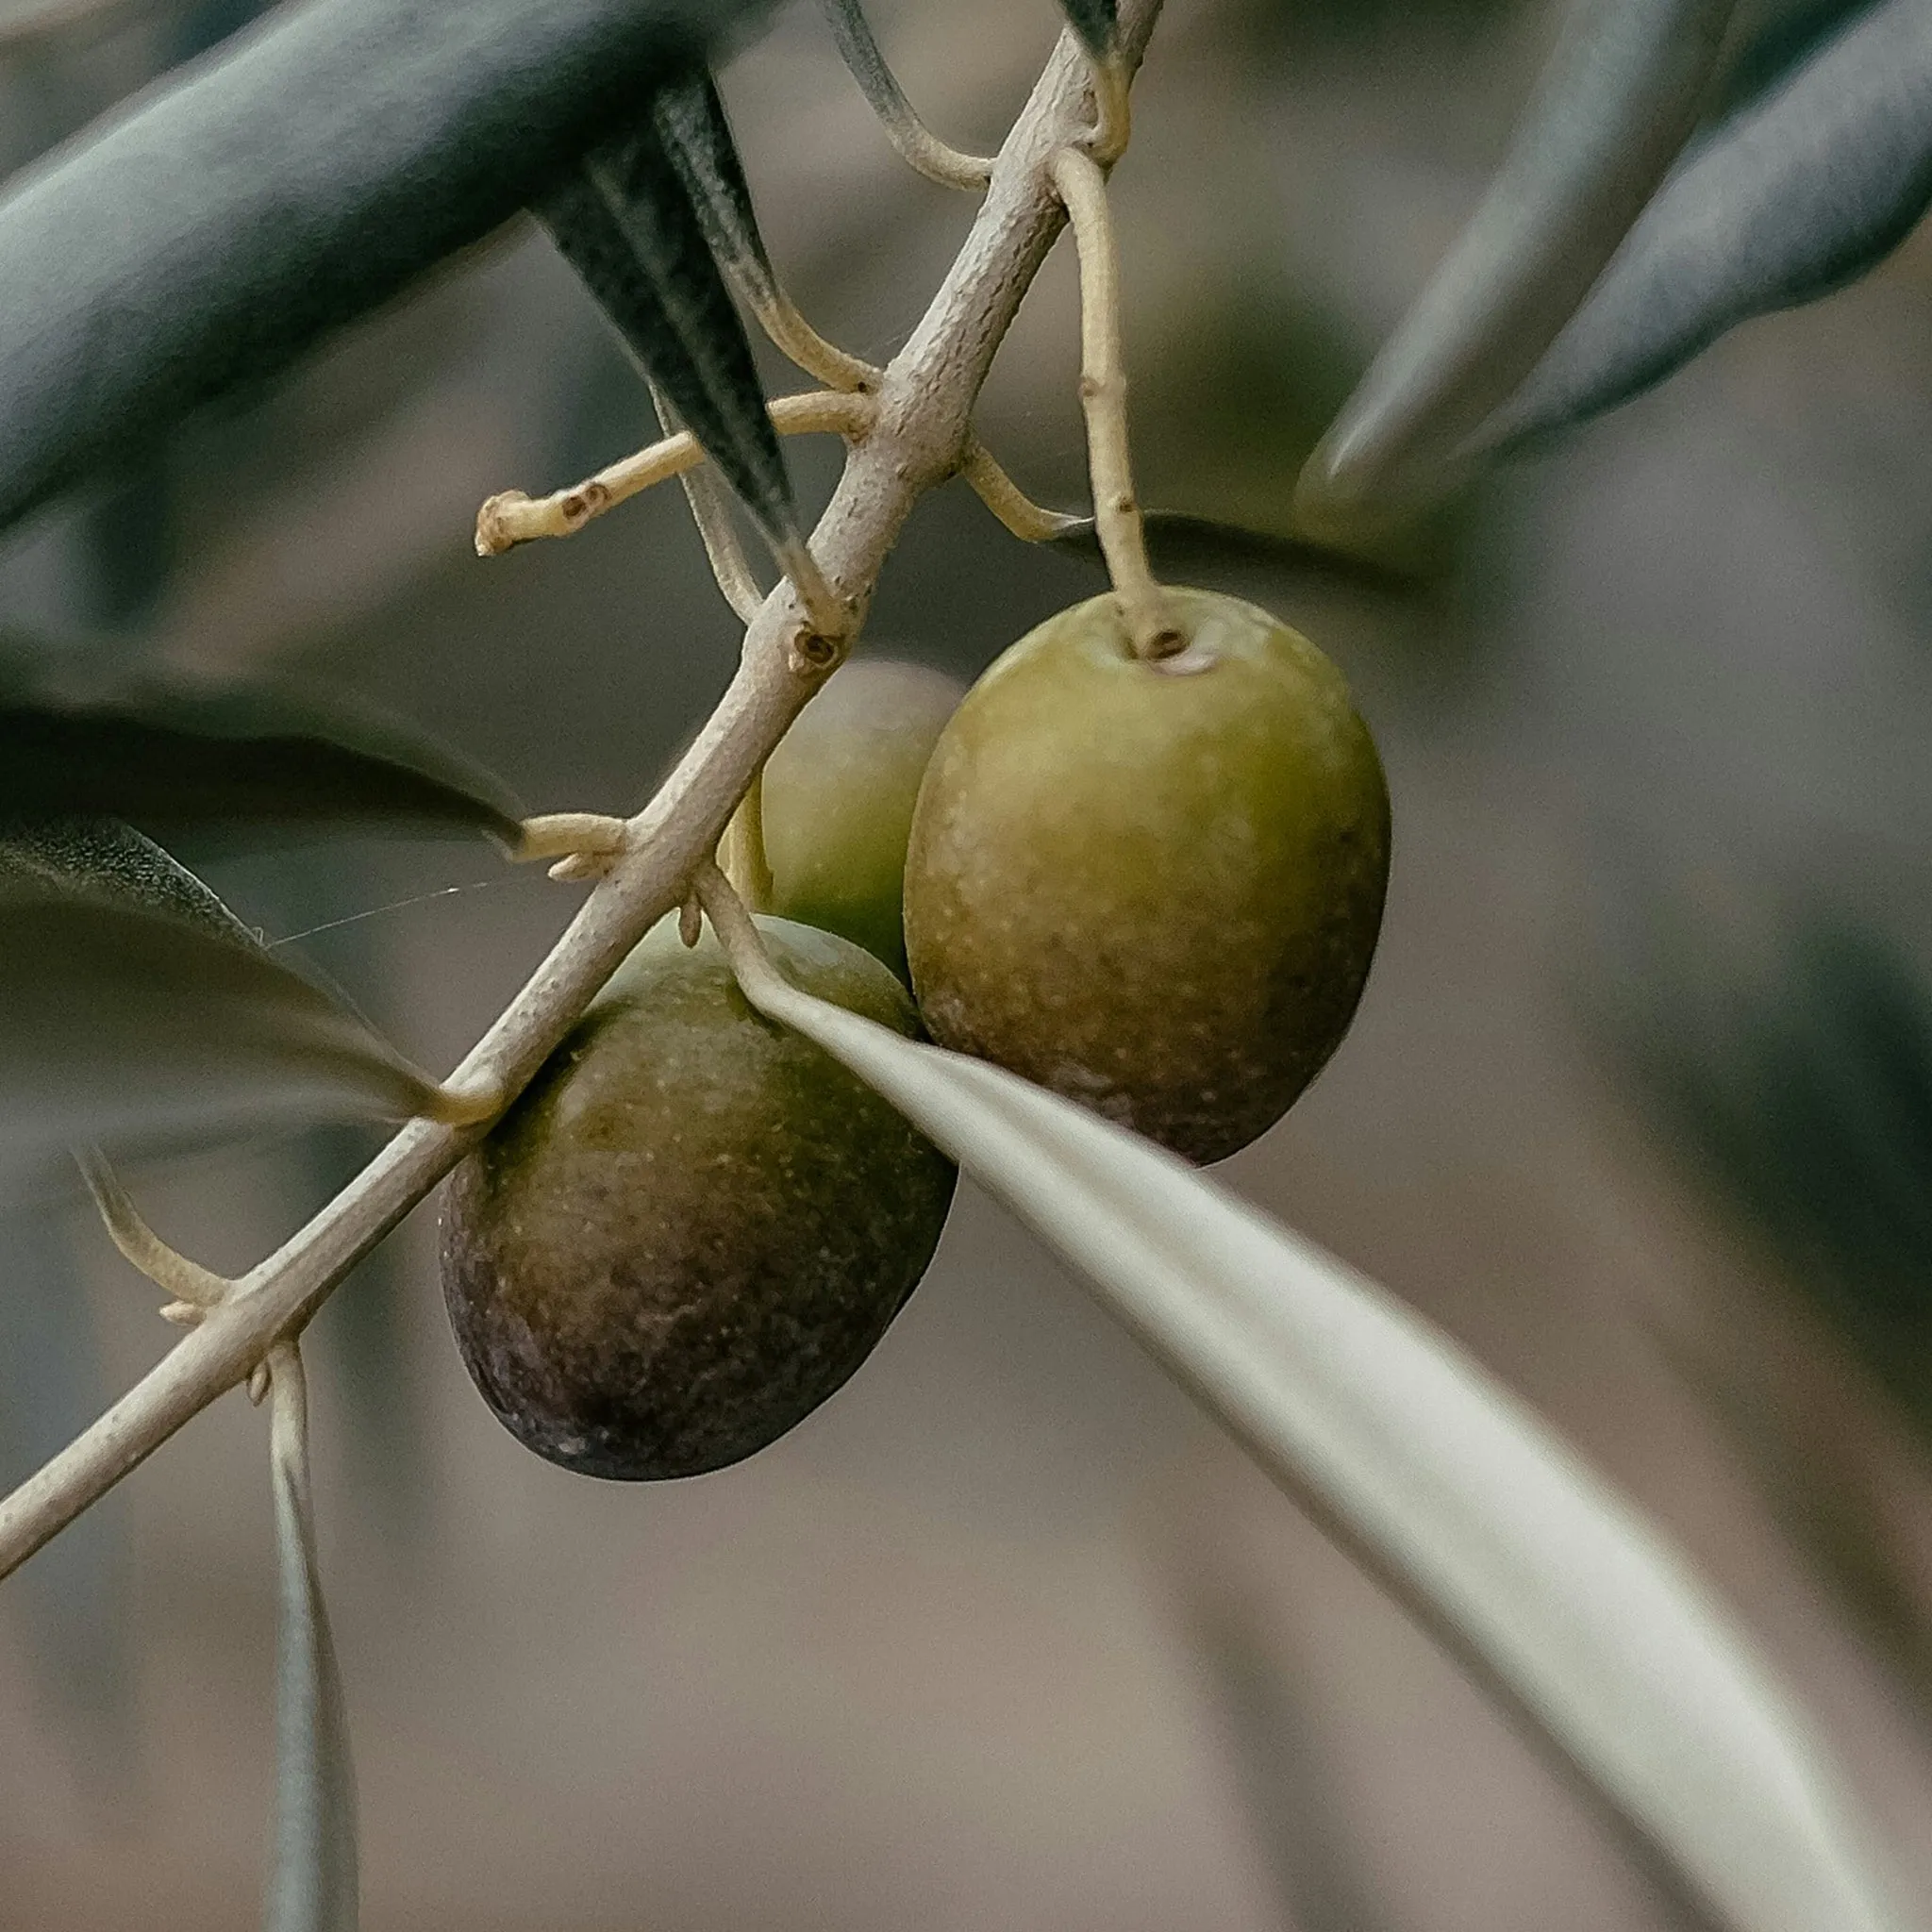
top-left (0, 0), bottom-right (1932, 1932)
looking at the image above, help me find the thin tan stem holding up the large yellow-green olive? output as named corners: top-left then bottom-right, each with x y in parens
top-left (1049, 147), bottom-right (1176, 657)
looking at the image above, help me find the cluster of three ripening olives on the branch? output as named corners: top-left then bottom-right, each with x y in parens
top-left (442, 590), bottom-right (1390, 1480)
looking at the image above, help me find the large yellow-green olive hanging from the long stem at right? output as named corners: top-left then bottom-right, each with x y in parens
top-left (907, 590), bottom-right (1390, 1161)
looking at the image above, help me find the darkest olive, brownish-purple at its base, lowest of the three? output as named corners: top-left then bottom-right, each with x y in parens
top-left (442, 920), bottom-right (955, 1482)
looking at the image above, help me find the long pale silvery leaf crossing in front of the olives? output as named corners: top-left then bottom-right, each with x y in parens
top-left (741, 946), bottom-right (1907, 1932)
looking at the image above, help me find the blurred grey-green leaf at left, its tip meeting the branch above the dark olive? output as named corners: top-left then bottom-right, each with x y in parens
top-left (0, 881), bottom-right (459, 1176)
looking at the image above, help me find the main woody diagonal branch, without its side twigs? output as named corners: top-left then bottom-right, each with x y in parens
top-left (0, 0), bottom-right (1161, 1576)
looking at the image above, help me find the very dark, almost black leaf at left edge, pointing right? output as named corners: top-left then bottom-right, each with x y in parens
top-left (0, 691), bottom-right (520, 844)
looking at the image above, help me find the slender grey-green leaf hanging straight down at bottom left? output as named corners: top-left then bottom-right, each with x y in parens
top-left (263, 1346), bottom-right (359, 1932)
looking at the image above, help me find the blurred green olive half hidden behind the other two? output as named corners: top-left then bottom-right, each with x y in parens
top-left (763, 658), bottom-right (964, 977)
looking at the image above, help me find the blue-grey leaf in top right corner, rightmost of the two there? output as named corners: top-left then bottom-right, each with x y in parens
top-left (1478, 0), bottom-right (1932, 450)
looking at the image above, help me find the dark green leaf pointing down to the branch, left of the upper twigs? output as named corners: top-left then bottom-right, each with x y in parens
top-left (541, 120), bottom-right (798, 545)
